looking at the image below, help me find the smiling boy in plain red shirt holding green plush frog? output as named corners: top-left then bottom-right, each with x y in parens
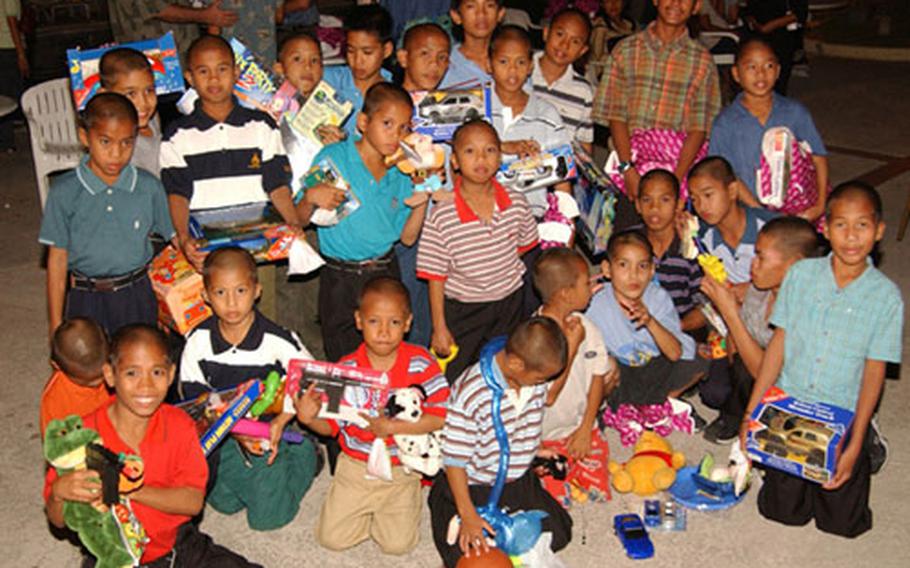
top-left (44, 324), bottom-right (256, 568)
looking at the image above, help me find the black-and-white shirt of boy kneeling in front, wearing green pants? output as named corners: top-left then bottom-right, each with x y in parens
top-left (180, 310), bottom-right (313, 400)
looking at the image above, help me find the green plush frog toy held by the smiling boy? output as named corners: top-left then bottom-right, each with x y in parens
top-left (44, 415), bottom-right (148, 568)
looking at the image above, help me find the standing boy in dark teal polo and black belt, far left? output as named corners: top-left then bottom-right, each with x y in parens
top-left (38, 93), bottom-right (175, 336)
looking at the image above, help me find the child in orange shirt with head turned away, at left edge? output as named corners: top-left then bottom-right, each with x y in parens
top-left (40, 318), bottom-right (111, 439)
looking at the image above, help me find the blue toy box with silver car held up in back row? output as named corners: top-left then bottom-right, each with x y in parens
top-left (411, 84), bottom-right (493, 142)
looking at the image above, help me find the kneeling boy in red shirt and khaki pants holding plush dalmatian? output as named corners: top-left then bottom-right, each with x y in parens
top-left (297, 276), bottom-right (449, 555)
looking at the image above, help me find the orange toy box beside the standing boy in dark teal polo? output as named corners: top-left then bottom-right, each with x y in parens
top-left (149, 245), bottom-right (212, 335)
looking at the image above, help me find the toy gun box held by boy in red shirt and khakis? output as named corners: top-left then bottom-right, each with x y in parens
top-left (287, 359), bottom-right (389, 425)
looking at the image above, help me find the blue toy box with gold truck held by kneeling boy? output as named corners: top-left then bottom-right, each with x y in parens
top-left (746, 387), bottom-right (853, 483)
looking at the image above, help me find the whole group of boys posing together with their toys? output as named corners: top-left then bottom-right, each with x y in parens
top-left (40, 0), bottom-right (903, 566)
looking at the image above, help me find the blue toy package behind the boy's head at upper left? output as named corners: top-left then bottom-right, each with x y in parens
top-left (66, 32), bottom-right (184, 110)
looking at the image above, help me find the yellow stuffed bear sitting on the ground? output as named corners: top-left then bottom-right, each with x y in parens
top-left (609, 431), bottom-right (686, 496)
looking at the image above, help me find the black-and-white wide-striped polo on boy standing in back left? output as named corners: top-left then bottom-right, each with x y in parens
top-left (160, 100), bottom-right (291, 210)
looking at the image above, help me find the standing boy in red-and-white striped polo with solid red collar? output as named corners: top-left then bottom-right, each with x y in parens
top-left (417, 120), bottom-right (538, 384)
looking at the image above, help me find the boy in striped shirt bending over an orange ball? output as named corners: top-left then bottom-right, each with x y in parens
top-left (428, 317), bottom-right (572, 568)
